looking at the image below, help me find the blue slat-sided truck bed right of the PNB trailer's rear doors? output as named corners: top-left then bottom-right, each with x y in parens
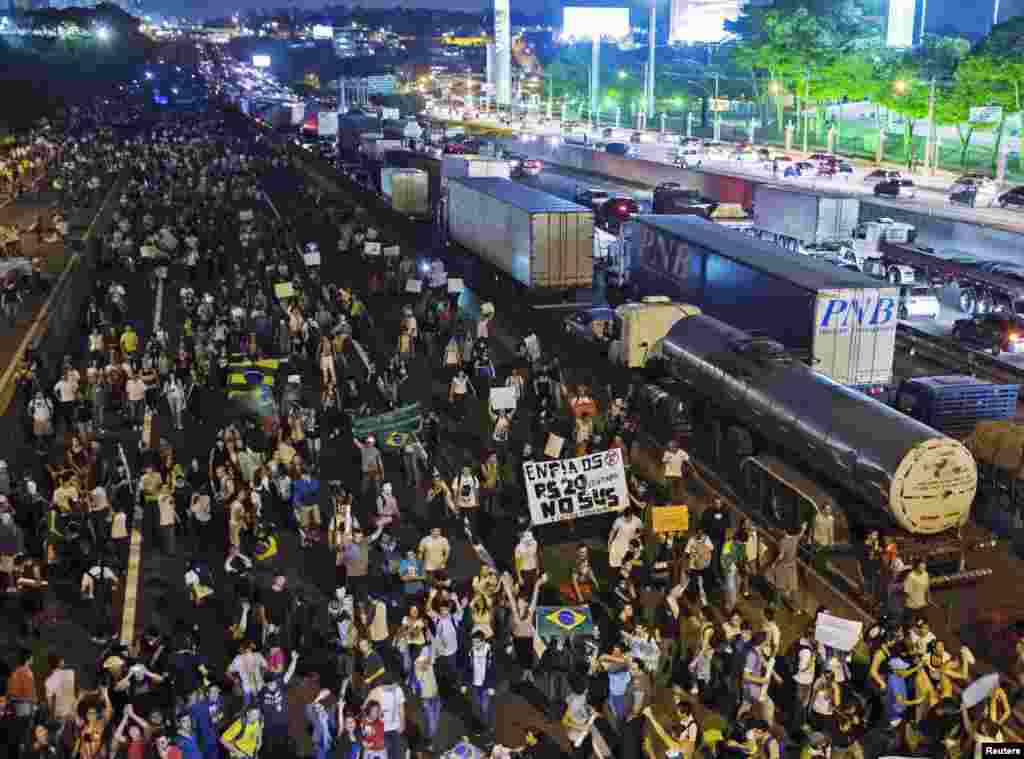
top-left (893, 375), bottom-right (1020, 438)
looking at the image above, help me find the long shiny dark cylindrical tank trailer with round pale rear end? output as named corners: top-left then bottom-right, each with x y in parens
top-left (652, 315), bottom-right (978, 569)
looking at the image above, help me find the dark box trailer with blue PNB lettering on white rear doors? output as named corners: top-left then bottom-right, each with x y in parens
top-left (609, 215), bottom-right (899, 396)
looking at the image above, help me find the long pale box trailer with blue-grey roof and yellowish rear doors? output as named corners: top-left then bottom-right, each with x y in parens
top-left (445, 177), bottom-right (594, 290)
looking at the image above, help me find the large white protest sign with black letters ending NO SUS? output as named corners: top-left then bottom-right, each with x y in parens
top-left (522, 449), bottom-right (629, 525)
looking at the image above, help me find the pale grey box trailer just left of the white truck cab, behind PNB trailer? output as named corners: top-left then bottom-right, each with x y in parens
top-left (754, 184), bottom-right (860, 251)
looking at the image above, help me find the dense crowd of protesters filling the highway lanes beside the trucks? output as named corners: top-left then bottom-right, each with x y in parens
top-left (0, 93), bottom-right (1024, 759)
